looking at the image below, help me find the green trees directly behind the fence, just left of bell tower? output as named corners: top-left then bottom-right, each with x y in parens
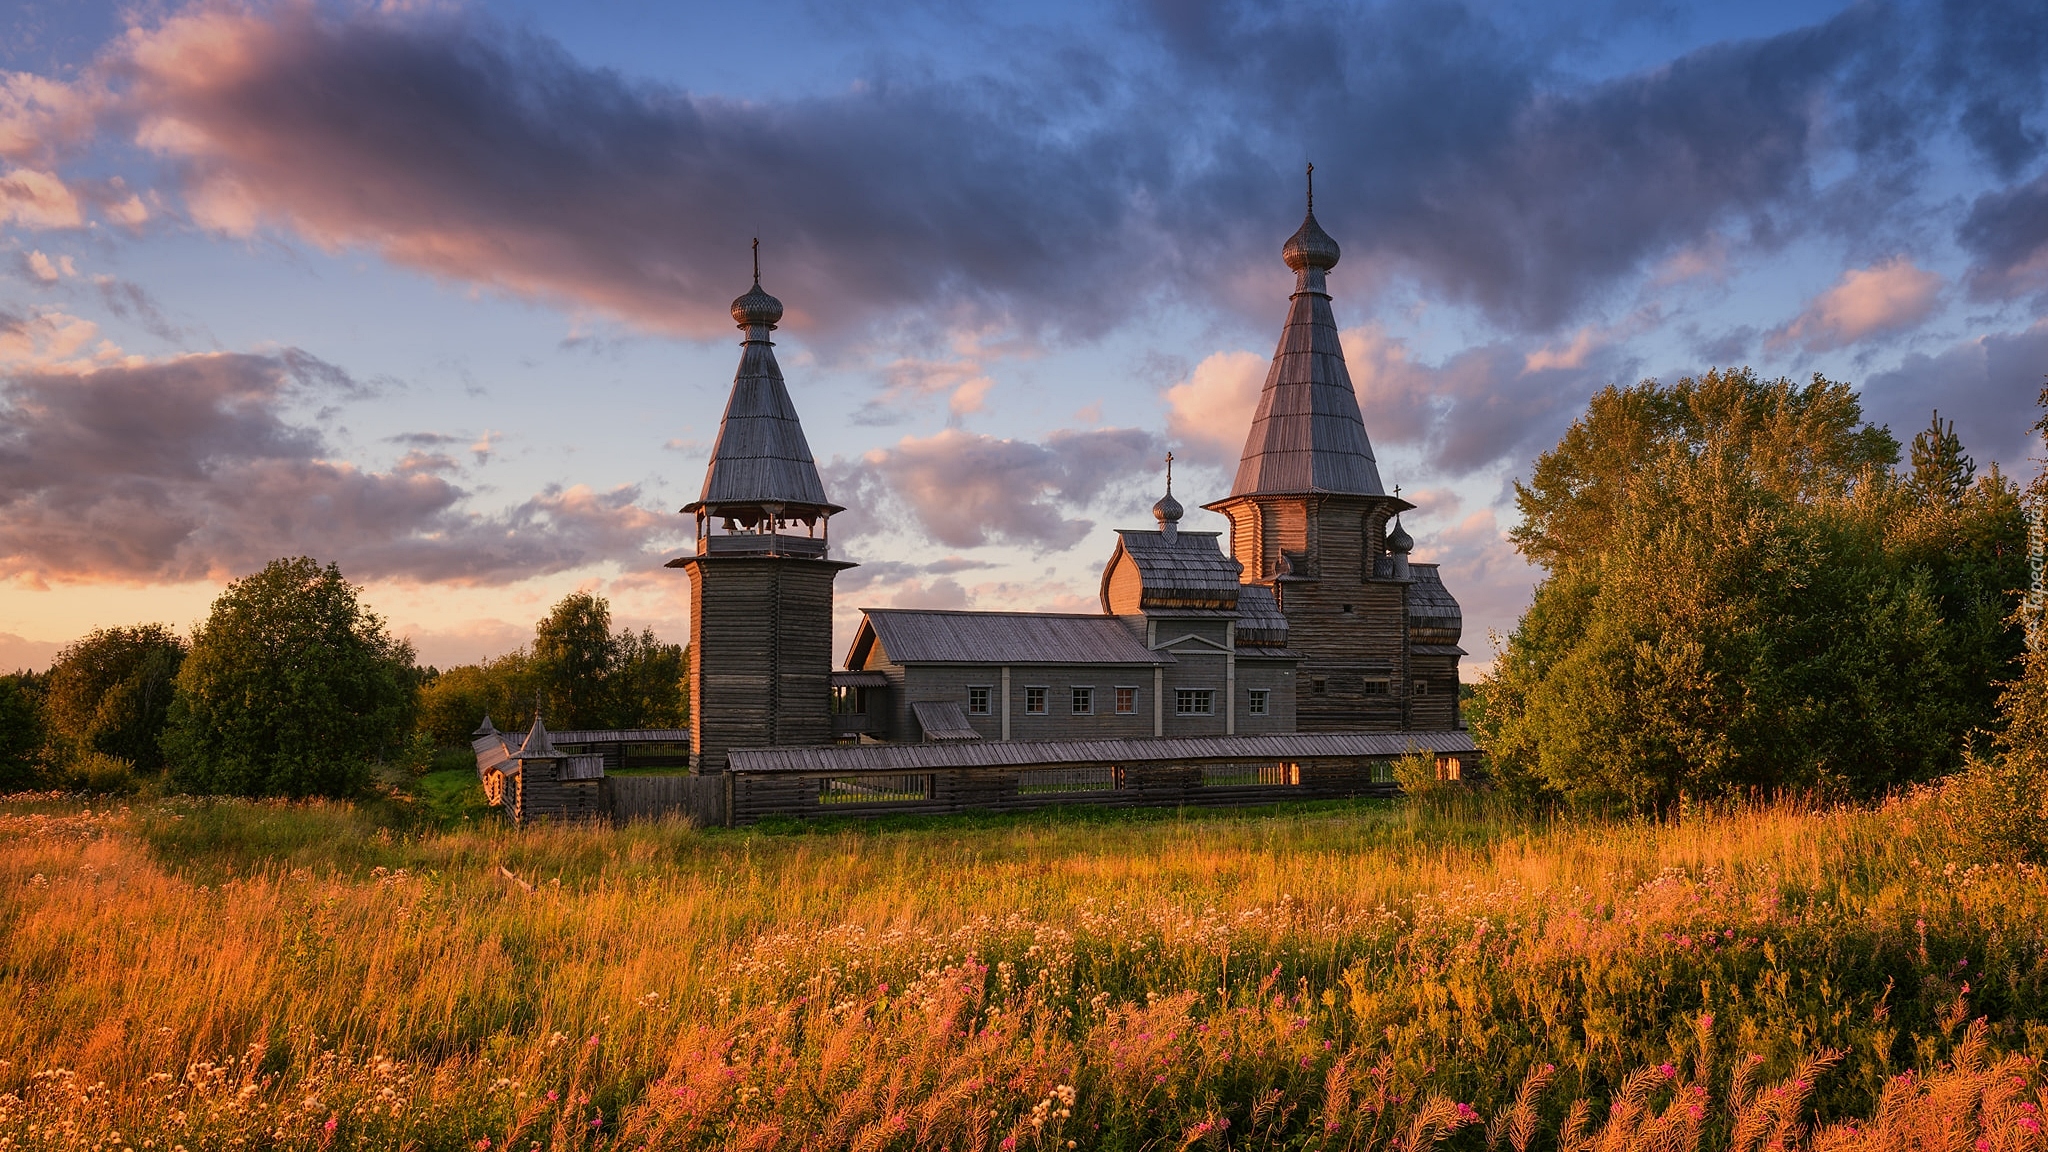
top-left (420, 592), bottom-right (690, 746)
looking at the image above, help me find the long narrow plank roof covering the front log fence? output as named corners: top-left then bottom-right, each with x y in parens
top-left (725, 728), bottom-right (1479, 773)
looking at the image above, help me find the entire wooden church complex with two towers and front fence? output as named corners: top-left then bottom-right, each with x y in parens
top-left (670, 177), bottom-right (1475, 787)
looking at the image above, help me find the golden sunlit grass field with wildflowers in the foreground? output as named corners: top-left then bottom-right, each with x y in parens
top-left (0, 773), bottom-right (2048, 1152)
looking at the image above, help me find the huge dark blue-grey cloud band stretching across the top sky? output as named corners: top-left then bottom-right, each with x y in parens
top-left (0, 2), bottom-right (2048, 336)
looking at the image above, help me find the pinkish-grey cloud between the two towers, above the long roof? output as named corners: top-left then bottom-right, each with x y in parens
top-left (823, 428), bottom-right (1163, 551)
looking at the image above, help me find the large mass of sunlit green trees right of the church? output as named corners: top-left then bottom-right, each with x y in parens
top-left (1475, 371), bottom-right (2023, 810)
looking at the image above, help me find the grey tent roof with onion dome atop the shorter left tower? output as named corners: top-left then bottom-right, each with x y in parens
top-left (684, 260), bottom-right (840, 515)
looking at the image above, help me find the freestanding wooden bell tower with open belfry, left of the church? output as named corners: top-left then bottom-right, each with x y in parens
top-left (668, 240), bottom-right (852, 773)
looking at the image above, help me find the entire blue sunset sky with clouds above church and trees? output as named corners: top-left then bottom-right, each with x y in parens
top-left (0, 0), bottom-right (2048, 674)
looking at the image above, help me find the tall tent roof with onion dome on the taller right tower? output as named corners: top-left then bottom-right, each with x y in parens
top-left (1231, 172), bottom-right (1386, 496)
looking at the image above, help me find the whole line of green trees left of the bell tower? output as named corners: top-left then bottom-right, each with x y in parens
top-left (0, 556), bottom-right (688, 797)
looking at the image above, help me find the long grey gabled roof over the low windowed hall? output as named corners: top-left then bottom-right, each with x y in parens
top-left (846, 609), bottom-right (1174, 668)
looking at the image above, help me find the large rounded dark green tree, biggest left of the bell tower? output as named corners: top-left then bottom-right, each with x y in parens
top-left (164, 556), bottom-right (418, 797)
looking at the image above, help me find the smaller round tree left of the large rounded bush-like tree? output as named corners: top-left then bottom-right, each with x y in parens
top-left (43, 623), bottom-right (186, 773)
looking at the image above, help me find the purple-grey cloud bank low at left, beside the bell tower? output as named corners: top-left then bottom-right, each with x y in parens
top-left (0, 353), bottom-right (676, 582)
